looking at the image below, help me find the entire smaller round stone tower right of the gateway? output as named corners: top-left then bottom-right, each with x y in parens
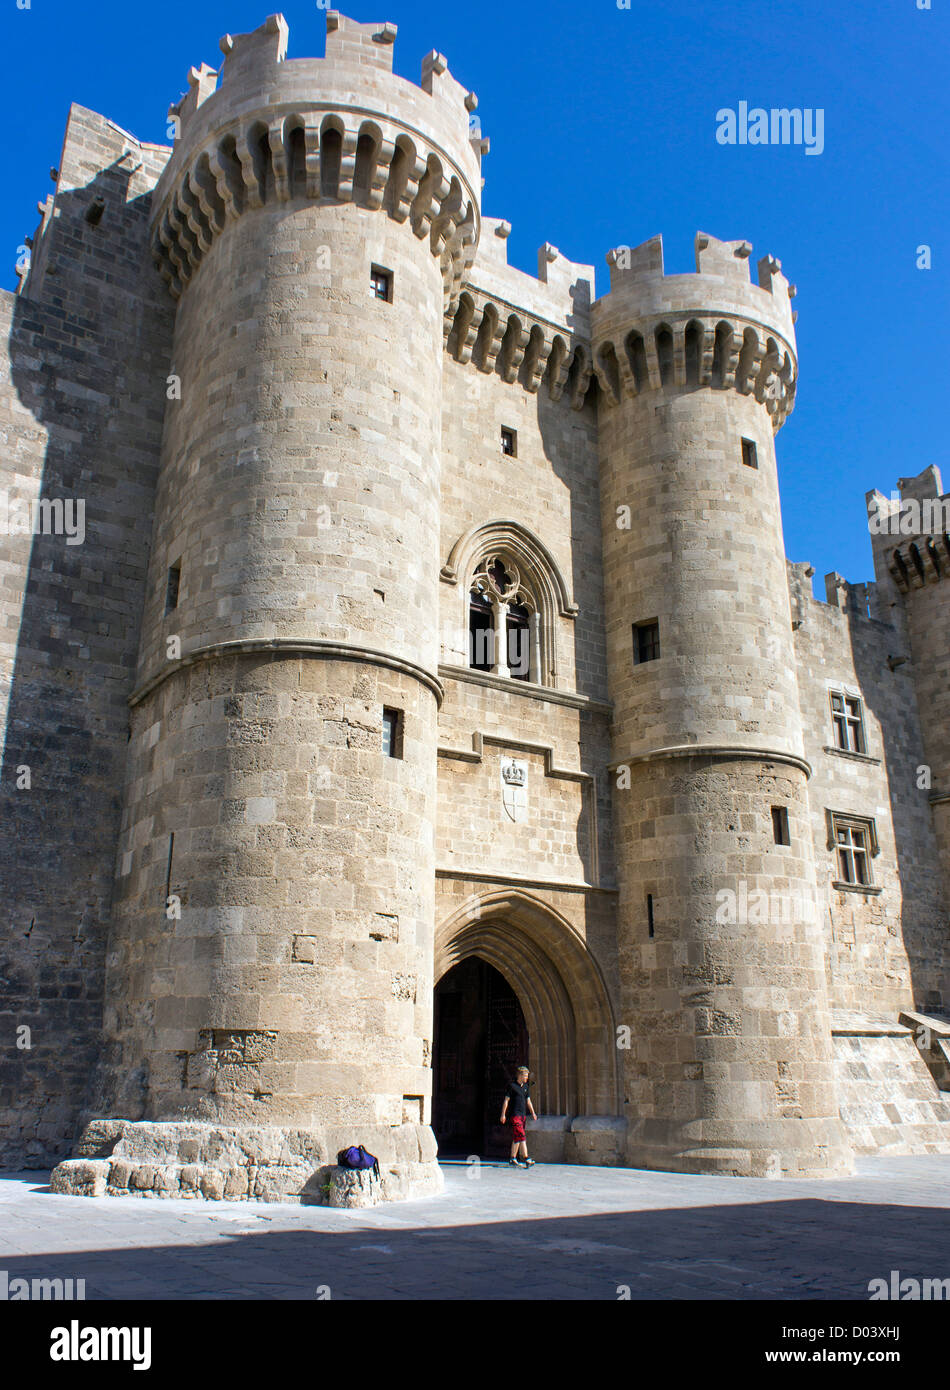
top-left (593, 235), bottom-right (850, 1177)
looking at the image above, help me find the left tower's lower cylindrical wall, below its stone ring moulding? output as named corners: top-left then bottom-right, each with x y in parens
top-left (106, 655), bottom-right (435, 1158)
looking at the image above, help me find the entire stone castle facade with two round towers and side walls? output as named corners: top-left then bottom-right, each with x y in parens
top-left (0, 11), bottom-right (950, 1198)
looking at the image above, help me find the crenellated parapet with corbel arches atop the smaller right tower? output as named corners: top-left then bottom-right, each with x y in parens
top-left (591, 232), bottom-right (797, 431)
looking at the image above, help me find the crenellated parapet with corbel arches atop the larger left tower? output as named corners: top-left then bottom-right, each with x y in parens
top-left (152, 10), bottom-right (488, 313)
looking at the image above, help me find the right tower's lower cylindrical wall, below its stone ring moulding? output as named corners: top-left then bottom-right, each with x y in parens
top-left (616, 756), bottom-right (847, 1176)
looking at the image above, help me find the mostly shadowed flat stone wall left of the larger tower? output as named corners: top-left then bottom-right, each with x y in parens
top-left (0, 106), bottom-right (171, 1168)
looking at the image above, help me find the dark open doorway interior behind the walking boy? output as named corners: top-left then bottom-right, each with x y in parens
top-left (433, 956), bottom-right (531, 1158)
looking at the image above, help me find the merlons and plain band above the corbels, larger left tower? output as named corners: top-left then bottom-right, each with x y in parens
top-left (156, 10), bottom-right (488, 237)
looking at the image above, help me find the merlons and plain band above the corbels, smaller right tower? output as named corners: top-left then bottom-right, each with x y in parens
top-left (593, 232), bottom-right (796, 356)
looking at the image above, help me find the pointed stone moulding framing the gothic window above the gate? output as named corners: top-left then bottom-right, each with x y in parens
top-left (440, 520), bottom-right (577, 689)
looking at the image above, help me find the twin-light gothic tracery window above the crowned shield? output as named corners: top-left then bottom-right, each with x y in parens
top-left (469, 555), bottom-right (541, 684)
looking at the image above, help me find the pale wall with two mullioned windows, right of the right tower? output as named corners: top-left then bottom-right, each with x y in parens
top-left (789, 564), bottom-right (947, 1016)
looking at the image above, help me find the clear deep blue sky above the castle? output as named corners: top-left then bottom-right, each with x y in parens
top-left (0, 0), bottom-right (950, 596)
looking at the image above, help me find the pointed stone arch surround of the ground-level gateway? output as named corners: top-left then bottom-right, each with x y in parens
top-left (434, 890), bottom-right (622, 1119)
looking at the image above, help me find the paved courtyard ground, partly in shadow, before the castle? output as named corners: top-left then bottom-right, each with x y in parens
top-left (0, 1156), bottom-right (950, 1300)
